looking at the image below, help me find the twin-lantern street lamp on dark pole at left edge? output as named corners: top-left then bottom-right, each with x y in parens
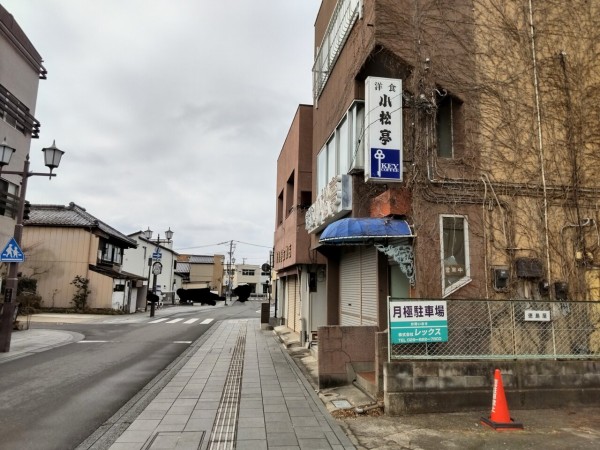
top-left (0, 138), bottom-right (65, 352)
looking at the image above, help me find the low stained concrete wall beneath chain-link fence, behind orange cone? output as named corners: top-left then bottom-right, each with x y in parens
top-left (383, 360), bottom-right (600, 416)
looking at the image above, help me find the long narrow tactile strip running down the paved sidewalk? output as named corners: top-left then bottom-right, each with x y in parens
top-left (208, 324), bottom-right (246, 450)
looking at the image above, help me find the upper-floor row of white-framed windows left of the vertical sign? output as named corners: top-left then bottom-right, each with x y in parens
top-left (317, 101), bottom-right (364, 193)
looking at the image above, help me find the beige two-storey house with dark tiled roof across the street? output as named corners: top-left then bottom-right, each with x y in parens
top-left (20, 203), bottom-right (145, 312)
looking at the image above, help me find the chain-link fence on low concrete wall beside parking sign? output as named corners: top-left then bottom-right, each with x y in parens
top-left (390, 298), bottom-right (600, 359)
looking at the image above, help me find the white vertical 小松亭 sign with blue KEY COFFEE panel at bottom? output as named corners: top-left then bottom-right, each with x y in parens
top-left (365, 77), bottom-right (402, 182)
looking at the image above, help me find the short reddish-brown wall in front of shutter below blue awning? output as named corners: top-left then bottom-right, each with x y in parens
top-left (319, 326), bottom-right (378, 389)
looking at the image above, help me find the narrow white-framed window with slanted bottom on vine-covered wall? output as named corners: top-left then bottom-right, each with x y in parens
top-left (440, 215), bottom-right (471, 297)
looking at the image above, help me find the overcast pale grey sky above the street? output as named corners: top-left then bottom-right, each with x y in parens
top-left (0, 0), bottom-right (320, 264)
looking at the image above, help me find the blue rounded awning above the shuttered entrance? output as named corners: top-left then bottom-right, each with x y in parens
top-left (319, 217), bottom-right (413, 244)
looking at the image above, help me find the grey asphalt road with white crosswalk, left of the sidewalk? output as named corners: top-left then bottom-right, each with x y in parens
top-left (0, 303), bottom-right (257, 450)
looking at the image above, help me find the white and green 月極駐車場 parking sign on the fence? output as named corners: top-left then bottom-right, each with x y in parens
top-left (389, 300), bottom-right (448, 344)
